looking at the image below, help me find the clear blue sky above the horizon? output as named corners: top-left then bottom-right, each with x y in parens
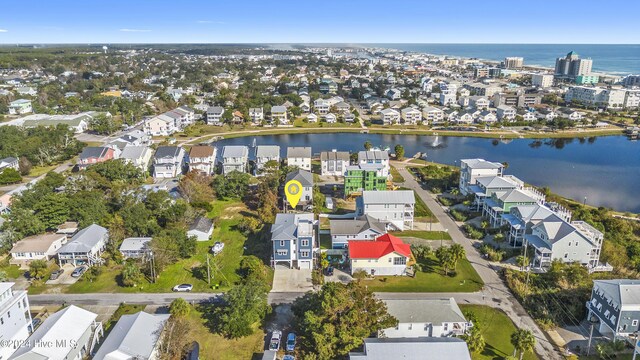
top-left (0, 0), bottom-right (640, 44)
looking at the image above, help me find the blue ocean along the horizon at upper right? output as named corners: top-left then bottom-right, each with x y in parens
top-left (362, 44), bottom-right (640, 75)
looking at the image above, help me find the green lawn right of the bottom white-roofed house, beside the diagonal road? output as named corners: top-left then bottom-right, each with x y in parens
top-left (460, 304), bottom-right (538, 360)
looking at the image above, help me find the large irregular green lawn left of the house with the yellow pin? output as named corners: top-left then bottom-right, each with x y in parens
top-left (64, 201), bottom-right (272, 293)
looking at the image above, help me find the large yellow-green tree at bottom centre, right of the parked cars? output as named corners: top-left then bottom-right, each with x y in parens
top-left (292, 282), bottom-right (398, 360)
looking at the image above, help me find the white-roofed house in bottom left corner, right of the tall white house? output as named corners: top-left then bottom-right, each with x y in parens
top-left (9, 305), bottom-right (103, 360)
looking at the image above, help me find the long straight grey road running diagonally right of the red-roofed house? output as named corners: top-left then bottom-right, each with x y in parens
top-left (393, 162), bottom-right (563, 360)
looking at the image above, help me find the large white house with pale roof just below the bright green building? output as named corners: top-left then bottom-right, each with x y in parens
top-left (356, 190), bottom-right (416, 231)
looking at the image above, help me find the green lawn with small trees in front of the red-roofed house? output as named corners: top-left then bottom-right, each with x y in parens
top-left (364, 255), bottom-right (484, 292)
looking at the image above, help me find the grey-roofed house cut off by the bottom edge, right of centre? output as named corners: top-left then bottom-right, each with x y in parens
top-left (349, 338), bottom-right (471, 360)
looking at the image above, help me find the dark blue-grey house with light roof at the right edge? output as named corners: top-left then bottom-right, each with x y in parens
top-left (587, 279), bottom-right (640, 342)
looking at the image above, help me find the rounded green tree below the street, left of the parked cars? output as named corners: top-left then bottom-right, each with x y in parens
top-left (219, 278), bottom-right (270, 339)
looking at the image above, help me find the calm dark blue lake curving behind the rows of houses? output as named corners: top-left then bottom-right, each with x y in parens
top-left (215, 133), bottom-right (640, 213)
